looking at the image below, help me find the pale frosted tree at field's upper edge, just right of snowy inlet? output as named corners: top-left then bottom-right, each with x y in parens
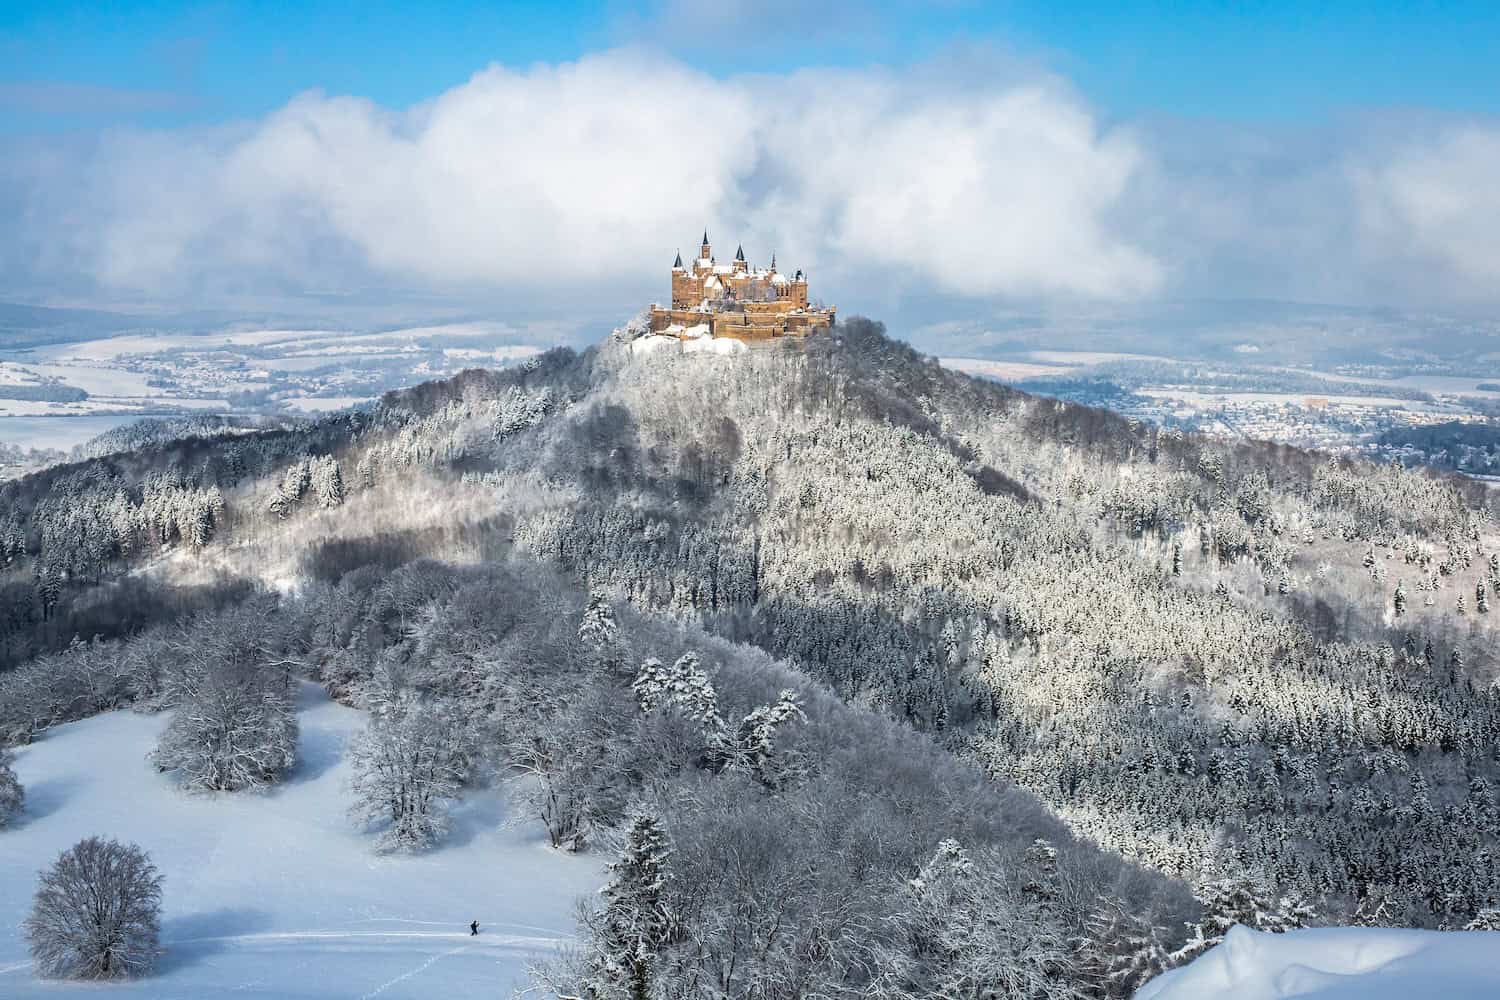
top-left (350, 694), bottom-right (474, 852)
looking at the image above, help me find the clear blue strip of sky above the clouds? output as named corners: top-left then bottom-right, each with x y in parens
top-left (0, 0), bottom-right (1500, 132)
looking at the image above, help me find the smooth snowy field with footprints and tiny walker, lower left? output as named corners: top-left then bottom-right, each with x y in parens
top-left (0, 685), bottom-right (605, 1000)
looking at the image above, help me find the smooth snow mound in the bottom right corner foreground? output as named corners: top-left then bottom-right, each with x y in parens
top-left (1136, 927), bottom-right (1500, 1000)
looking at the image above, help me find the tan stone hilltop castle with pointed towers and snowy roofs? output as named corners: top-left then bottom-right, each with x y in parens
top-left (651, 231), bottom-right (834, 340)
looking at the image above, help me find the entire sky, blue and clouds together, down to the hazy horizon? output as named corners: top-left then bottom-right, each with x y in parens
top-left (0, 0), bottom-right (1500, 335)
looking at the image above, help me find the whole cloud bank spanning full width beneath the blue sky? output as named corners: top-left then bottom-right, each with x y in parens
top-left (0, 49), bottom-right (1500, 314)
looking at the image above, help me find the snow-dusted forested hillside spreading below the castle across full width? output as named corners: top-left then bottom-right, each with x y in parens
top-left (0, 319), bottom-right (1500, 996)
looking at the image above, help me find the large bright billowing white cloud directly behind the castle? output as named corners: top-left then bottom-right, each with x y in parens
top-left (2, 51), bottom-right (1161, 305)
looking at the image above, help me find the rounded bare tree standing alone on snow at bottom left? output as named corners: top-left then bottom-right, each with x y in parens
top-left (23, 837), bottom-right (162, 979)
